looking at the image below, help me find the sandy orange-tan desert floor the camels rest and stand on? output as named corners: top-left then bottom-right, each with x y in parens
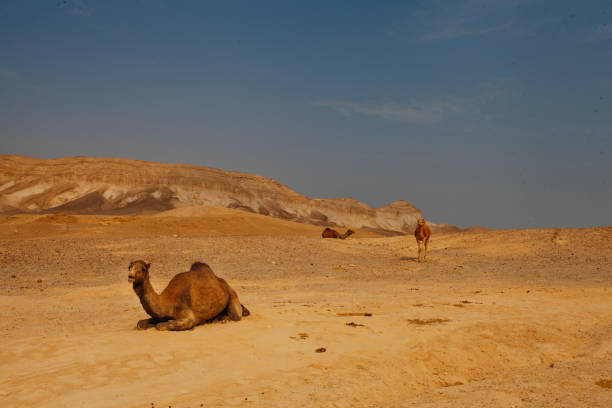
top-left (0, 208), bottom-right (612, 408)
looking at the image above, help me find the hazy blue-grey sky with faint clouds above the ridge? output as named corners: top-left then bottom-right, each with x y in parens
top-left (0, 0), bottom-right (612, 228)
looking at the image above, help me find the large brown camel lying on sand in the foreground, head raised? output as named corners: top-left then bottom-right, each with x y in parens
top-left (128, 261), bottom-right (250, 330)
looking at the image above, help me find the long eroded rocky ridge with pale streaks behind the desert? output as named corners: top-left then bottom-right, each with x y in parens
top-left (0, 155), bottom-right (421, 234)
